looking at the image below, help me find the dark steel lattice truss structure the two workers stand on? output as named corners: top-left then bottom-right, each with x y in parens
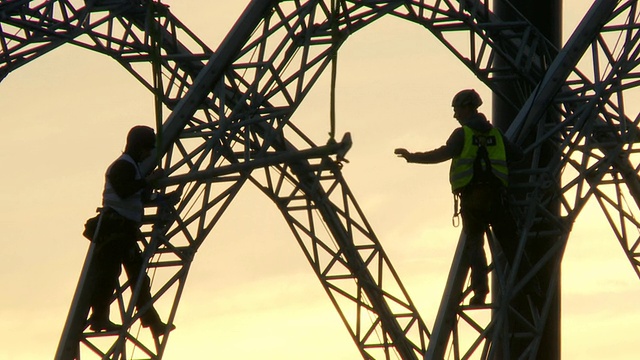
top-left (0, 0), bottom-right (640, 359)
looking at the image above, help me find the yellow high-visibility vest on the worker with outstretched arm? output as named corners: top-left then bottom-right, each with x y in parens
top-left (449, 126), bottom-right (509, 192)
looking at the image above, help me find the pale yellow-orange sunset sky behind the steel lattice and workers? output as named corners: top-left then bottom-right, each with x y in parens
top-left (0, 0), bottom-right (640, 360)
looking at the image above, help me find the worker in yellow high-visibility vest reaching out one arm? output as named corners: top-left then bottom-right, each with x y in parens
top-left (395, 89), bottom-right (522, 305)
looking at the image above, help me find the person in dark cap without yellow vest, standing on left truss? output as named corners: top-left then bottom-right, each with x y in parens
top-left (88, 126), bottom-right (175, 337)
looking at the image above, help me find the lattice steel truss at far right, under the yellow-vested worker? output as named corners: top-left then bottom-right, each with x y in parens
top-left (428, 1), bottom-right (640, 358)
